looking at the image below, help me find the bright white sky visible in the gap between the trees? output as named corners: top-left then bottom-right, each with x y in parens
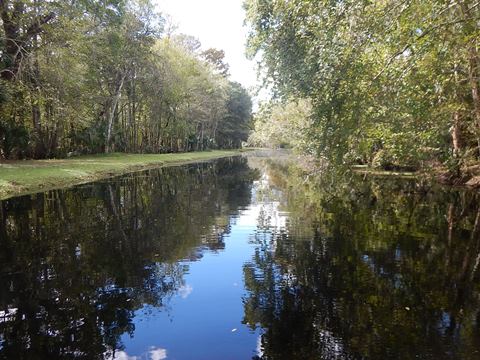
top-left (155, 0), bottom-right (257, 88)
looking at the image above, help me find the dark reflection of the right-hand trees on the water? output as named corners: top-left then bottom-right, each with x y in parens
top-left (244, 162), bottom-right (480, 359)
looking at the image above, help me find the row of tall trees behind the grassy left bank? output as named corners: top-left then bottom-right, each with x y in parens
top-left (0, 0), bottom-right (252, 159)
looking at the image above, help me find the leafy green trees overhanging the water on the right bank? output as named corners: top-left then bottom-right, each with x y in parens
top-left (245, 0), bottom-right (480, 176)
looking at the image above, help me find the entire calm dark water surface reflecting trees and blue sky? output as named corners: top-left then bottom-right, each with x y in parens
top-left (0, 156), bottom-right (480, 360)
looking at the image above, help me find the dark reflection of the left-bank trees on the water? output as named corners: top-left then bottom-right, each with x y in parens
top-left (0, 158), bottom-right (257, 359)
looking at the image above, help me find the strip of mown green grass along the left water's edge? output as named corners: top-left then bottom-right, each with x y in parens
top-left (0, 150), bottom-right (240, 199)
